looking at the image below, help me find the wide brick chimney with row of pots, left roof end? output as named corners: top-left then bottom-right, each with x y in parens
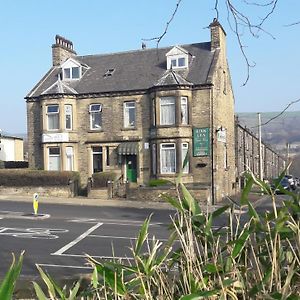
top-left (52, 35), bottom-right (77, 66)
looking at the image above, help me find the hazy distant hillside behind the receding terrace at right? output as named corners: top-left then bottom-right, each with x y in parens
top-left (236, 111), bottom-right (300, 155)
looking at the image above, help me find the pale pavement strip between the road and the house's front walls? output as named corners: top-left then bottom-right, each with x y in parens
top-left (0, 193), bottom-right (263, 211)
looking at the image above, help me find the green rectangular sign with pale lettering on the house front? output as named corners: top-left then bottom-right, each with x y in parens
top-left (193, 127), bottom-right (210, 156)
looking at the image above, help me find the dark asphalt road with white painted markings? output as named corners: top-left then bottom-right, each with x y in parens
top-left (0, 201), bottom-right (174, 279)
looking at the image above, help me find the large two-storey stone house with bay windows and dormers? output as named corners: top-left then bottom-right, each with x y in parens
top-left (26, 20), bottom-right (236, 201)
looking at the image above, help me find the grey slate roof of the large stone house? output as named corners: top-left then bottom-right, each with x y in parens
top-left (26, 42), bottom-right (214, 98)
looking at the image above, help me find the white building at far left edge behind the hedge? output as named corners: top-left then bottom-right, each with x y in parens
top-left (0, 135), bottom-right (24, 161)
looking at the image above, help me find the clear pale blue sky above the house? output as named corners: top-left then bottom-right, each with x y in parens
top-left (0, 0), bottom-right (300, 134)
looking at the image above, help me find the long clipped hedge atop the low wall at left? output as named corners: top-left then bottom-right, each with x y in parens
top-left (0, 169), bottom-right (79, 187)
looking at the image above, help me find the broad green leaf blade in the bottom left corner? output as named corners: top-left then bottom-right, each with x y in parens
top-left (0, 251), bottom-right (24, 300)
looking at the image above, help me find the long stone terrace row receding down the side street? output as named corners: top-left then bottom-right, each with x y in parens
top-left (236, 121), bottom-right (286, 188)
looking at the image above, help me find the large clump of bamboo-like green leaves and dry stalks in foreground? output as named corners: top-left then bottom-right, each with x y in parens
top-left (86, 170), bottom-right (300, 300)
